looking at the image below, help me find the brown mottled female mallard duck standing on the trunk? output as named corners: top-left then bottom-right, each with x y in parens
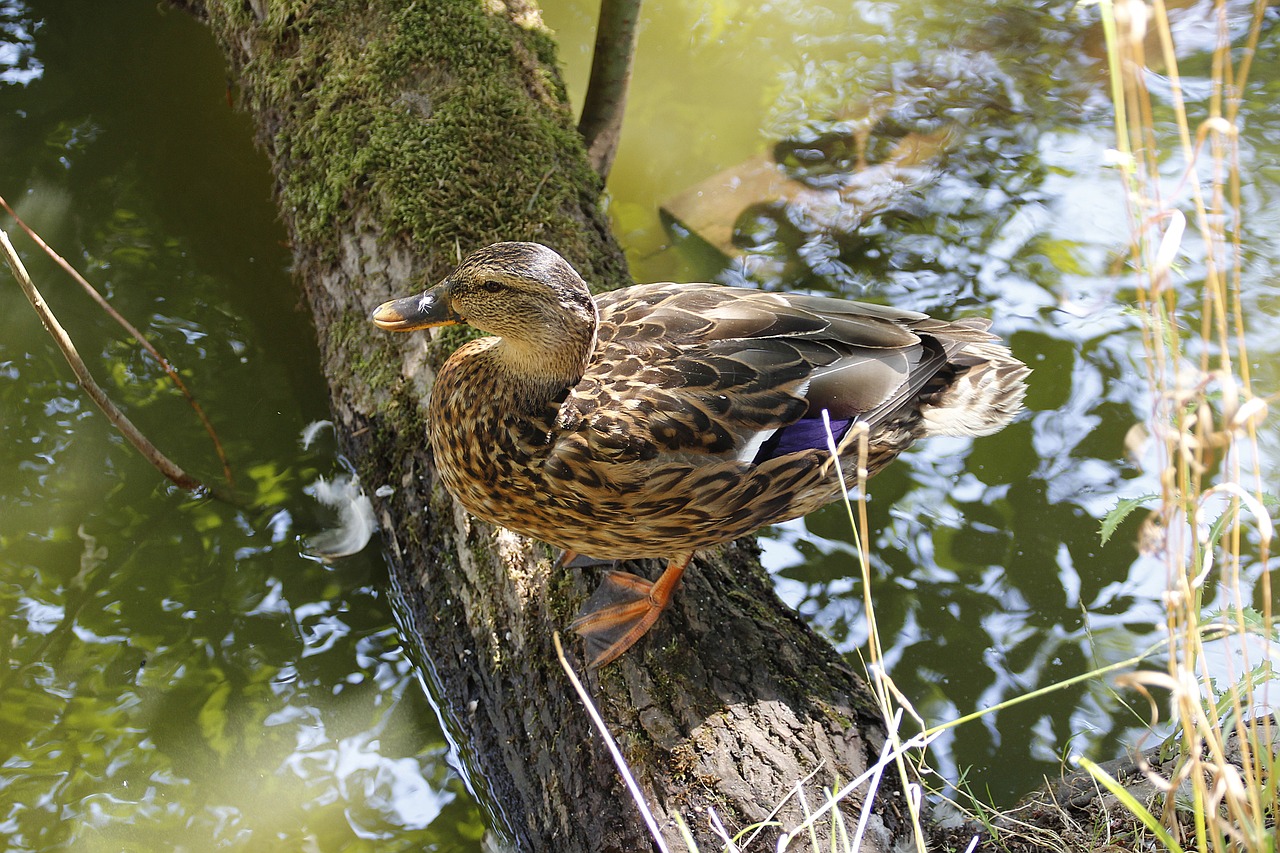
top-left (374, 243), bottom-right (1029, 666)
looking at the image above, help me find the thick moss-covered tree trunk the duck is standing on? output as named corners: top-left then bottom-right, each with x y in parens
top-left (175, 0), bottom-right (901, 853)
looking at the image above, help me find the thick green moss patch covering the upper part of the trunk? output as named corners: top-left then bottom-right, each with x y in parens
top-left (204, 0), bottom-right (613, 278)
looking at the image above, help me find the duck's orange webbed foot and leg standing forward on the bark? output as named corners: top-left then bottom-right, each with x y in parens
top-left (570, 553), bottom-right (692, 670)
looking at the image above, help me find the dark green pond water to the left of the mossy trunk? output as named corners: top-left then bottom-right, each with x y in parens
top-left (0, 1), bottom-right (485, 850)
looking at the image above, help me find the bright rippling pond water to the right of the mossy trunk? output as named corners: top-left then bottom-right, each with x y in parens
top-left (548, 0), bottom-right (1280, 802)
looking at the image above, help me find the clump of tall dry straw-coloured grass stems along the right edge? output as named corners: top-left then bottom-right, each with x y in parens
top-left (1101, 0), bottom-right (1277, 850)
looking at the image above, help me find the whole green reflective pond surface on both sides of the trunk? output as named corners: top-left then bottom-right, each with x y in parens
top-left (0, 0), bottom-right (1280, 850)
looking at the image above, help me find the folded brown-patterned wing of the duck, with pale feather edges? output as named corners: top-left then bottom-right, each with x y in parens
top-left (561, 284), bottom-right (992, 462)
